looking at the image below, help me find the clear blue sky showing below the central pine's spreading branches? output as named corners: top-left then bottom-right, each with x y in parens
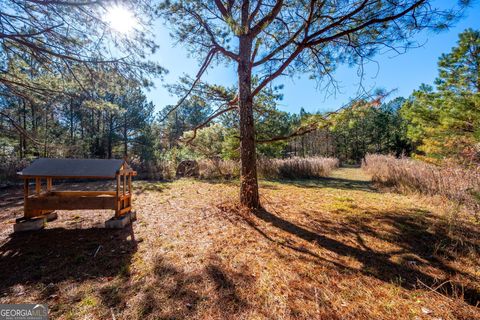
top-left (147, 0), bottom-right (480, 113)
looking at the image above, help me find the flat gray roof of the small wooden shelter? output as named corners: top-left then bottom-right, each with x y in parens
top-left (18, 158), bottom-right (124, 178)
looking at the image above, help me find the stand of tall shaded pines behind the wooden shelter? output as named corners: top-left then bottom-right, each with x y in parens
top-left (0, 64), bottom-right (158, 165)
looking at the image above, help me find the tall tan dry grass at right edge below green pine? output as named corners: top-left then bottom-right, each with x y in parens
top-left (362, 154), bottom-right (480, 214)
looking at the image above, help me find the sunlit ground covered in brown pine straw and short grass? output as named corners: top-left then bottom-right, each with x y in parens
top-left (0, 168), bottom-right (480, 320)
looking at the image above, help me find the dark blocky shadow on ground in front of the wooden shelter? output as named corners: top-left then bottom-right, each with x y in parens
top-left (0, 227), bottom-right (137, 295)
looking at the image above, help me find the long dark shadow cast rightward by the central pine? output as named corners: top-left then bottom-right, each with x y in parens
top-left (251, 209), bottom-right (480, 306)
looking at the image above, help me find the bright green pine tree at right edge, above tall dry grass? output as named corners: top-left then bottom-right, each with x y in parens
top-left (401, 29), bottom-right (480, 163)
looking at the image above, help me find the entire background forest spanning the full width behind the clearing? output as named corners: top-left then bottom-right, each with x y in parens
top-left (0, 26), bottom-right (480, 181)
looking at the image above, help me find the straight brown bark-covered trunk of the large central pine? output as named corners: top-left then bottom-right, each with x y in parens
top-left (237, 35), bottom-right (260, 209)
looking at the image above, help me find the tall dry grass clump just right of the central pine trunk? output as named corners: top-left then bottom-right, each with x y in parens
top-left (258, 157), bottom-right (339, 179)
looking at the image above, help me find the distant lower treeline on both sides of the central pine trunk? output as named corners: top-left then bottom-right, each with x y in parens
top-left (163, 98), bottom-right (413, 163)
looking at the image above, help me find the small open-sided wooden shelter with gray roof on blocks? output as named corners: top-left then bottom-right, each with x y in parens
top-left (18, 158), bottom-right (137, 219)
